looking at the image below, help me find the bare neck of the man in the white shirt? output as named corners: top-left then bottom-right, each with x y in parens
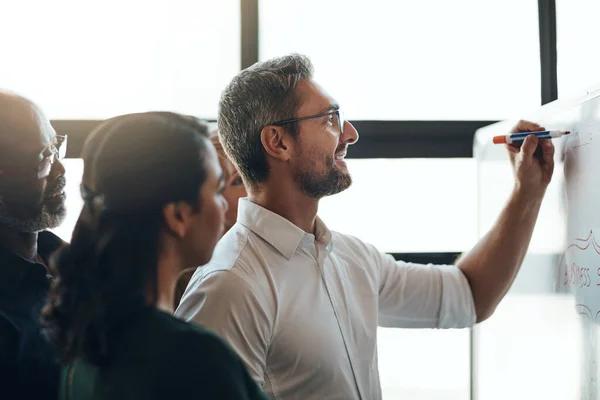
top-left (248, 184), bottom-right (319, 234)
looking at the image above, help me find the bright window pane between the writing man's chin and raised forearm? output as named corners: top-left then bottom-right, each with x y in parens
top-left (319, 158), bottom-right (477, 253)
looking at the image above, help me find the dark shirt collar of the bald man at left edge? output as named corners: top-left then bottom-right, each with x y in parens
top-left (0, 231), bottom-right (65, 294)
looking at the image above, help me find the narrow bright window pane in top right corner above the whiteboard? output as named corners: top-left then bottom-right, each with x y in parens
top-left (556, 0), bottom-right (600, 98)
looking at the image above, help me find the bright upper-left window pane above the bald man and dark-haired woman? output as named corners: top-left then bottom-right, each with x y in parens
top-left (0, 0), bottom-right (240, 119)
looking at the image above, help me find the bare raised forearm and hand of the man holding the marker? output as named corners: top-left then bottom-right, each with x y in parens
top-left (456, 121), bottom-right (554, 322)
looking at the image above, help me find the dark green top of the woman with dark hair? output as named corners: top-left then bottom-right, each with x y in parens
top-left (60, 308), bottom-right (267, 400)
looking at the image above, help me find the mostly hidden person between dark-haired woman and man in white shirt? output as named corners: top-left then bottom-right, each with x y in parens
top-left (174, 132), bottom-right (247, 308)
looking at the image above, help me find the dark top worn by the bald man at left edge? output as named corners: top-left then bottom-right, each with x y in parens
top-left (0, 232), bottom-right (64, 400)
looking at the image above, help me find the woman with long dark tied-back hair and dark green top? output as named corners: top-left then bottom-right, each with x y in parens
top-left (43, 112), bottom-right (266, 400)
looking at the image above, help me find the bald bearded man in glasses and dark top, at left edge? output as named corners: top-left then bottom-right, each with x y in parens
top-left (0, 91), bottom-right (66, 399)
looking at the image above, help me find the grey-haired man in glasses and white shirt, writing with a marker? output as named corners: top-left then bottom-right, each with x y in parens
top-left (176, 54), bottom-right (554, 400)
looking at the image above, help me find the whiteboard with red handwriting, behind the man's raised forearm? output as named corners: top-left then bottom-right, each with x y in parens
top-left (473, 86), bottom-right (600, 400)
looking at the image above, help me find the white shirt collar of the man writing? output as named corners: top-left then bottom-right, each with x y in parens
top-left (237, 198), bottom-right (332, 260)
